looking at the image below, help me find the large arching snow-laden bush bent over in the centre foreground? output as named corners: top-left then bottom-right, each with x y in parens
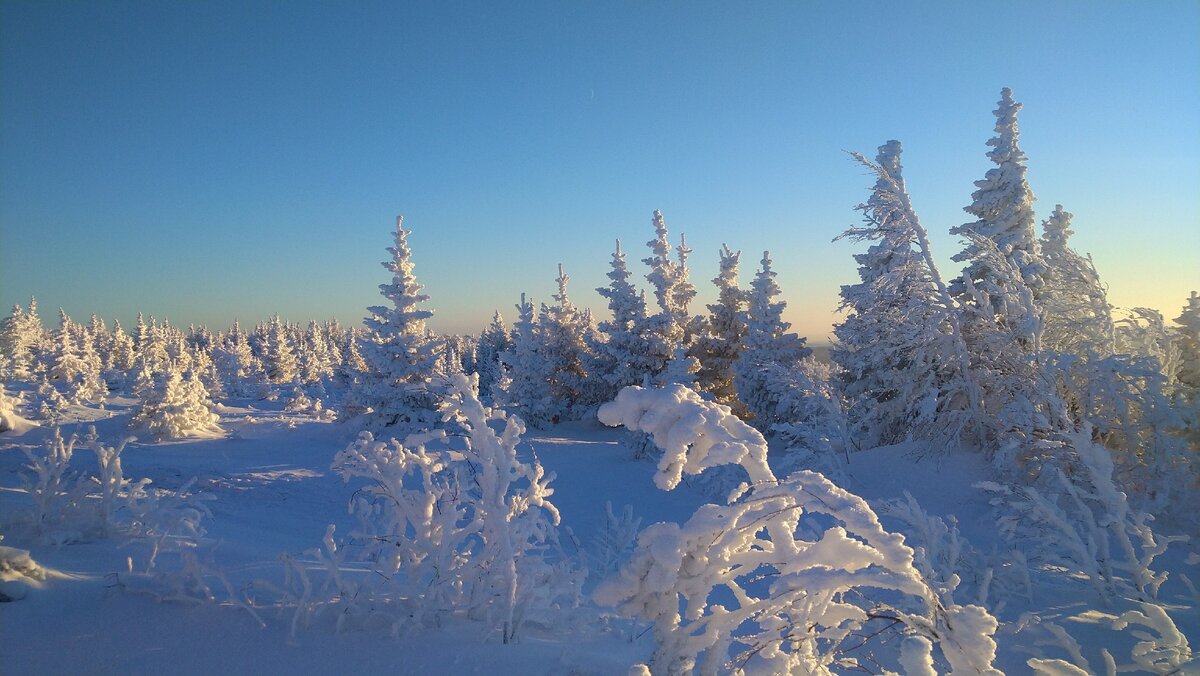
top-left (595, 385), bottom-right (998, 674)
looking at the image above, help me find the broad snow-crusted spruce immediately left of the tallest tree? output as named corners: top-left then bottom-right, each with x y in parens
top-left (830, 140), bottom-right (978, 448)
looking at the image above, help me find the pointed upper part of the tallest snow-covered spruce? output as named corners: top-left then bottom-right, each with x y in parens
top-left (950, 86), bottom-right (1046, 303)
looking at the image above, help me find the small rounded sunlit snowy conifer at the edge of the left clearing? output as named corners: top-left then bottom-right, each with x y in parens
top-left (130, 369), bottom-right (224, 439)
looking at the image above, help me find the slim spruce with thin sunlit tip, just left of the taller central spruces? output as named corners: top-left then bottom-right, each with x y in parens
top-left (540, 263), bottom-right (604, 421)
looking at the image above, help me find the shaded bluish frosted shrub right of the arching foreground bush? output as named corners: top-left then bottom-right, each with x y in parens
top-left (977, 424), bottom-right (1181, 604)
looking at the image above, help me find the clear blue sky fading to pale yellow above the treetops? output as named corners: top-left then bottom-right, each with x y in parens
top-left (0, 0), bottom-right (1200, 343)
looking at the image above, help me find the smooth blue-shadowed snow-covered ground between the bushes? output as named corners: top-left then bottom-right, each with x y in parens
top-left (0, 400), bottom-right (1200, 675)
